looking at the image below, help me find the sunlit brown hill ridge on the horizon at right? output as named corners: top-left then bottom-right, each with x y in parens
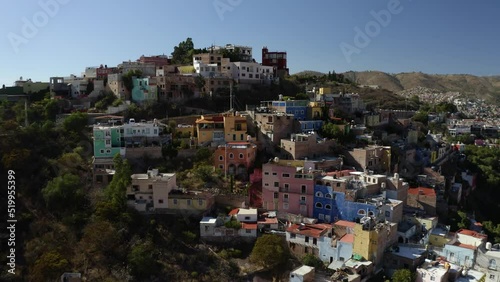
top-left (344, 71), bottom-right (500, 100)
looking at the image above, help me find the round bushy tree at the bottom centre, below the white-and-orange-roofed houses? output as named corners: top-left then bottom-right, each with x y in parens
top-left (250, 234), bottom-right (289, 268)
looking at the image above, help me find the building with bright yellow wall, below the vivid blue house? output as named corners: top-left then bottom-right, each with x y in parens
top-left (353, 217), bottom-right (397, 266)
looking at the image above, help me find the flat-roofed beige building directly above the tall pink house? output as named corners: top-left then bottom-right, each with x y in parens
top-left (281, 133), bottom-right (335, 160)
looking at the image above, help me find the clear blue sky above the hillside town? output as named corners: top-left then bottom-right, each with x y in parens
top-left (0, 0), bottom-right (500, 86)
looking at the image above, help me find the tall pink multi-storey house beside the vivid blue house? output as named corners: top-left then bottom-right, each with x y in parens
top-left (262, 160), bottom-right (321, 217)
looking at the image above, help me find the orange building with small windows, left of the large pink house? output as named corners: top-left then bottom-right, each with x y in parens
top-left (214, 142), bottom-right (257, 179)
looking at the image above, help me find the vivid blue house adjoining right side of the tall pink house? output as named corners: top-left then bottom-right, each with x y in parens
top-left (313, 185), bottom-right (380, 222)
